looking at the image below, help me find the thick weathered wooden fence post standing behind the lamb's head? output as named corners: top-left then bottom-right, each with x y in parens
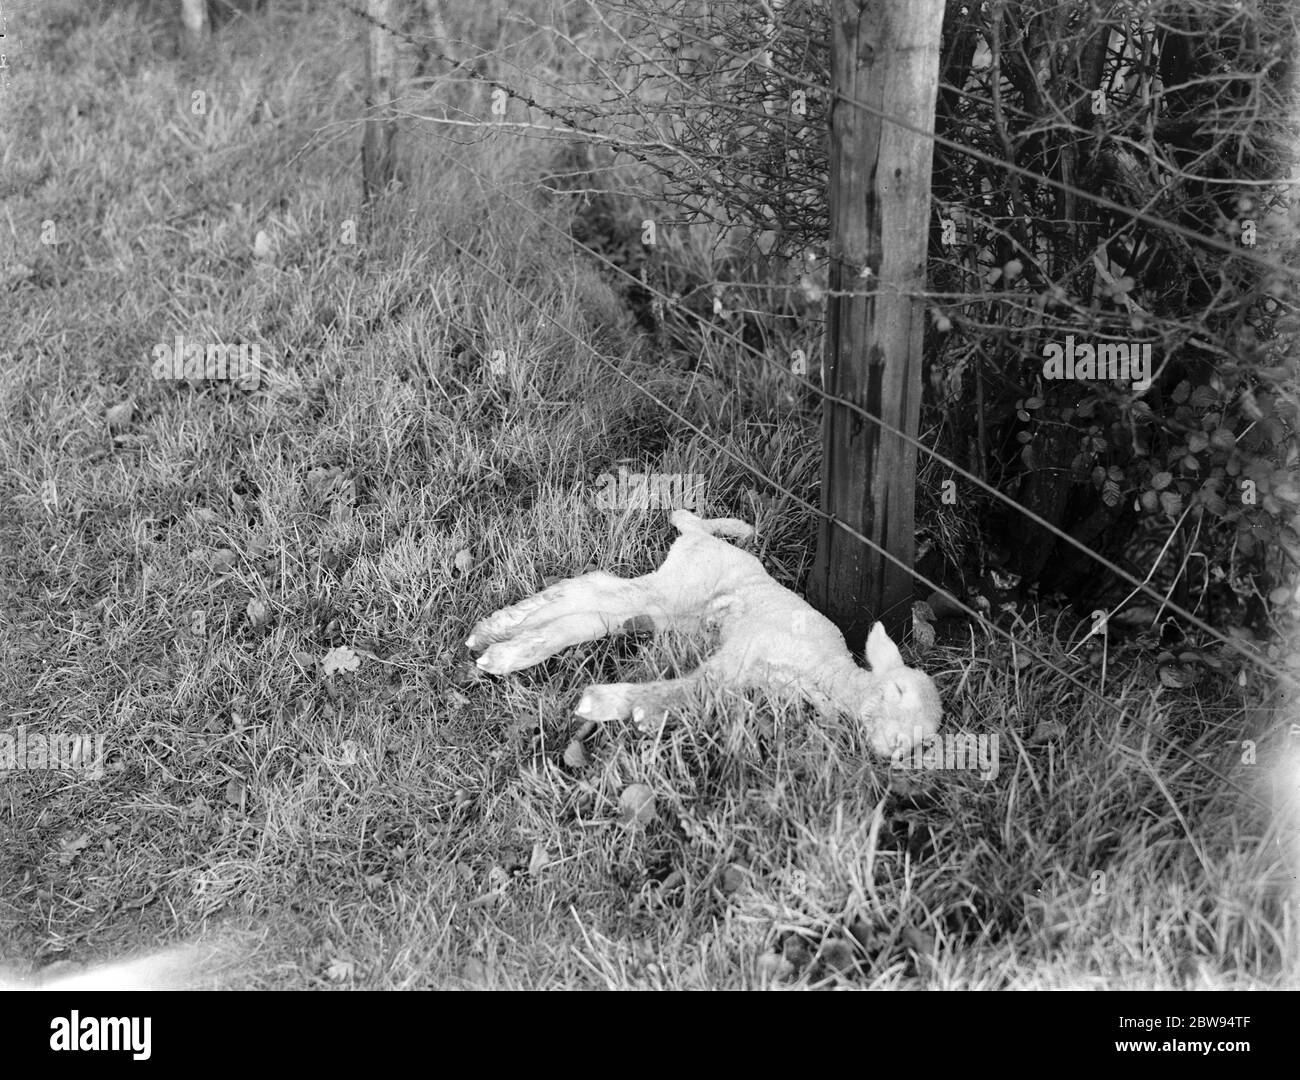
top-left (809, 0), bottom-right (944, 651)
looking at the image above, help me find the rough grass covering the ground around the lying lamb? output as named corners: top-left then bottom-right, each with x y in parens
top-left (0, 0), bottom-right (1297, 989)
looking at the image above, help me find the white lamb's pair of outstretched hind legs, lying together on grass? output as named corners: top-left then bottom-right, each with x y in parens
top-left (465, 571), bottom-right (657, 675)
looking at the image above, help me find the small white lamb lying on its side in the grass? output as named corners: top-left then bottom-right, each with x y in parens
top-left (465, 509), bottom-right (943, 755)
